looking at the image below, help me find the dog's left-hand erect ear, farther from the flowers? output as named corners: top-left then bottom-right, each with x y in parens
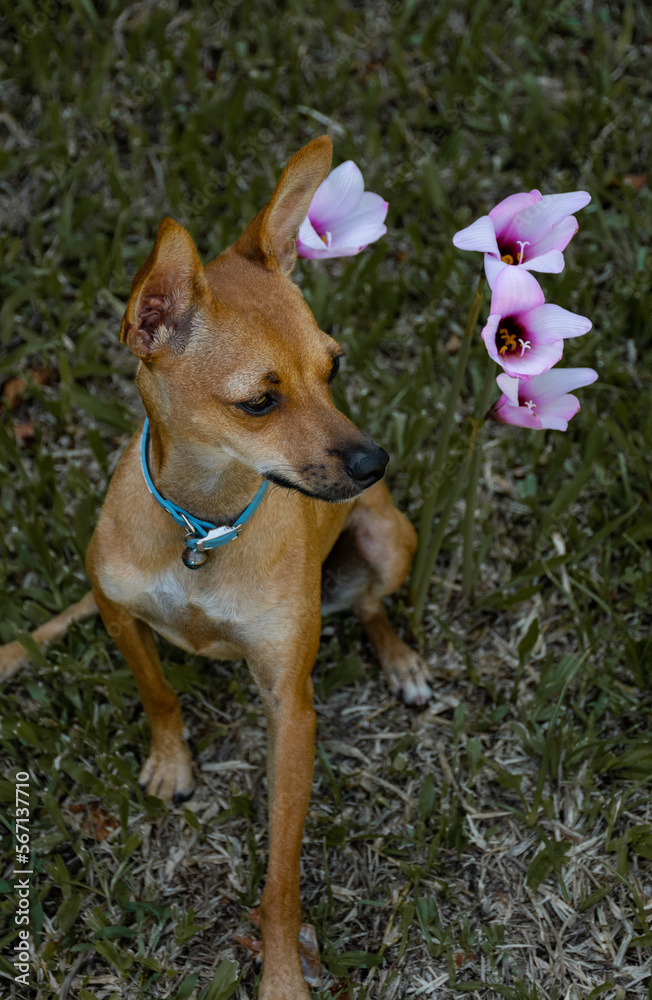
top-left (120, 219), bottom-right (208, 361)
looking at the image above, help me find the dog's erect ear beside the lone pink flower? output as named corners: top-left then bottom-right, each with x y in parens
top-left (233, 135), bottom-right (333, 274)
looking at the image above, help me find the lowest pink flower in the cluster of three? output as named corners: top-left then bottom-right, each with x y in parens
top-left (491, 368), bottom-right (598, 431)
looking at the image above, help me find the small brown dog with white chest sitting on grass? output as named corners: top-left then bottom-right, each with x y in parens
top-left (0, 136), bottom-right (430, 1000)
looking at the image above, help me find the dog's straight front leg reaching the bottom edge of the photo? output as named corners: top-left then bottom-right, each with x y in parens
top-left (250, 614), bottom-right (319, 1000)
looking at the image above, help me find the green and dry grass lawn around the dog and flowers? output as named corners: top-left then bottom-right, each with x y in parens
top-left (0, 0), bottom-right (652, 1000)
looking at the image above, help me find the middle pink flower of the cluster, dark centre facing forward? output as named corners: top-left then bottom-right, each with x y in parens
top-left (482, 267), bottom-right (592, 379)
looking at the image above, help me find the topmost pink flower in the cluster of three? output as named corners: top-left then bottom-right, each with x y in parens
top-left (453, 189), bottom-right (591, 288)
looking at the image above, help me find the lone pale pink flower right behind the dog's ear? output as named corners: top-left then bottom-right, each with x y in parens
top-left (297, 160), bottom-right (387, 258)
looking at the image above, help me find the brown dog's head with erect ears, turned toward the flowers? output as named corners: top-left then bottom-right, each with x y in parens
top-left (120, 136), bottom-right (388, 501)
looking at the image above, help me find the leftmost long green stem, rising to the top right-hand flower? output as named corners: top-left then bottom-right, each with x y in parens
top-left (410, 274), bottom-right (485, 601)
